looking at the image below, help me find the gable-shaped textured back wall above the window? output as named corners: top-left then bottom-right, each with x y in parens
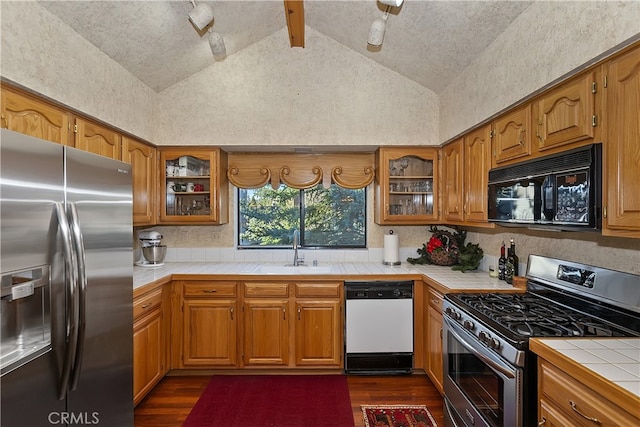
top-left (154, 27), bottom-right (439, 146)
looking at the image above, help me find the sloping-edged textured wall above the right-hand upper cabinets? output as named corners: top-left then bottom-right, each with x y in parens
top-left (440, 0), bottom-right (640, 142)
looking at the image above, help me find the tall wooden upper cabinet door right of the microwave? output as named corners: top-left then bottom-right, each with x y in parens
top-left (602, 47), bottom-right (640, 238)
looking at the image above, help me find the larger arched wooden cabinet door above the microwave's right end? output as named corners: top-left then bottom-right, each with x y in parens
top-left (533, 72), bottom-right (597, 154)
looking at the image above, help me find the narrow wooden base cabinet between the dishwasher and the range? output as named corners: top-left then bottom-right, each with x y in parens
top-left (426, 288), bottom-right (444, 394)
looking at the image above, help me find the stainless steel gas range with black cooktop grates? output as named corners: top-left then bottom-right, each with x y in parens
top-left (443, 255), bottom-right (640, 427)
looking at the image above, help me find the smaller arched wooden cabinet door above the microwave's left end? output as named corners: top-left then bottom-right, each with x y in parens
top-left (491, 104), bottom-right (531, 167)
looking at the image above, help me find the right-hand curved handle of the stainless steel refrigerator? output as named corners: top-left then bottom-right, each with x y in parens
top-left (69, 203), bottom-right (87, 390)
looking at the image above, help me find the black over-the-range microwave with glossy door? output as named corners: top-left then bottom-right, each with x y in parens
top-left (489, 144), bottom-right (602, 230)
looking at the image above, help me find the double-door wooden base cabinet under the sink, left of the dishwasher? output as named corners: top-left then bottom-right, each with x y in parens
top-left (242, 282), bottom-right (343, 368)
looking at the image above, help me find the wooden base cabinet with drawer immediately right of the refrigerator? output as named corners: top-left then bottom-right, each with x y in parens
top-left (133, 288), bottom-right (169, 405)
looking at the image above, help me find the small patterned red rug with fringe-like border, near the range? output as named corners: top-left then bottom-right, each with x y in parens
top-left (362, 405), bottom-right (437, 427)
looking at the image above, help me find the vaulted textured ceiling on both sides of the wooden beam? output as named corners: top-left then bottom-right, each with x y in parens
top-left (39, 0), bottom-right (531, 93)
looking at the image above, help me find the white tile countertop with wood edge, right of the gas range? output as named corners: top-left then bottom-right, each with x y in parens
top-left (530, 338), bottom-right (640, 398)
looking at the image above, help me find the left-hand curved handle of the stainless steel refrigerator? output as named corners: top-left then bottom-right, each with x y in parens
top-left (56, 202), bottom-right (79, 400)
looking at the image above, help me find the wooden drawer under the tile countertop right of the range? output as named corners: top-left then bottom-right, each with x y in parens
top-left (539, 360), bottom-right (640, 426)
